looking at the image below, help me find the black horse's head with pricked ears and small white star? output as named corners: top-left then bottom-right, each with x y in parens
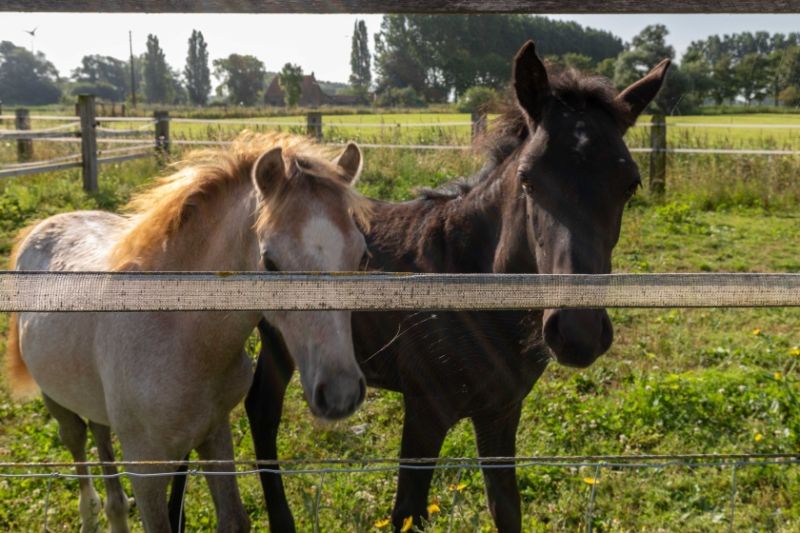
top-left (513, 41), bottom-right (669, 367)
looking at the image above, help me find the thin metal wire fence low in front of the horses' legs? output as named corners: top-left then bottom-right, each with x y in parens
top-left (0, 453), bottom-right (800, 532)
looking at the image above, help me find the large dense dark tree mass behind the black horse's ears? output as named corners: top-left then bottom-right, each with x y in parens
top-left (375, 15), bottom-right (622, 101)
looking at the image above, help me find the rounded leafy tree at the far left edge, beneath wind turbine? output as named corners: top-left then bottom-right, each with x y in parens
top-left (0, 41), bottom-right (61, 105)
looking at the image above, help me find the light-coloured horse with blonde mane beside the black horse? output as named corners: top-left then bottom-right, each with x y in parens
top-left (8, 134), bottom-right (368, 532)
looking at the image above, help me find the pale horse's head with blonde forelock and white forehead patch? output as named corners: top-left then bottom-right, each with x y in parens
top-left (252, 144), bottom-right (367, 419)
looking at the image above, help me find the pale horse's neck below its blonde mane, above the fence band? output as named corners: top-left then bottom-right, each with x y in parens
top-left (153, 187), bottom-right (258, 271)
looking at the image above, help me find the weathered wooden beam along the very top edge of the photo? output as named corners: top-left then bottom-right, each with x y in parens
top-left (6, 0), bottom-right (800, 14)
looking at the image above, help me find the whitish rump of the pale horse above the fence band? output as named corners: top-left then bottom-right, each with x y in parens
top-left (16, 211), bottom-right (127, 271)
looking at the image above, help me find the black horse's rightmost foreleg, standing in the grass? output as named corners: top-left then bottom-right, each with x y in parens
top-left (472, 404), bottom-right (522, 533)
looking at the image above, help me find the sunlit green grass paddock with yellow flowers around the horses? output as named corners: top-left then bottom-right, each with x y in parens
top-left (0, 115), bottom-right (800, 532)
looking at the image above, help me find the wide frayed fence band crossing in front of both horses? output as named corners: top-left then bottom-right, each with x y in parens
top-left (0, 271), bottom-right (800, 311)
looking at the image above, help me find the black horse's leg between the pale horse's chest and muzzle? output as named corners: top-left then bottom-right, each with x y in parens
top-left (244, 320), bottom-right (295, 533)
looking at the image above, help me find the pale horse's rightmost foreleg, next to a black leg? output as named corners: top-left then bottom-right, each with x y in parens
top-left (197, 417), bottom-right (250, 533)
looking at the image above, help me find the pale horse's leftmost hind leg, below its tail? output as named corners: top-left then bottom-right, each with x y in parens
top-left (44, 395), bottom-right (102, 533)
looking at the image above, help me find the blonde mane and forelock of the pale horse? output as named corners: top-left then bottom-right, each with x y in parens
top-left (110, 131), bottom-right (369, 270)
